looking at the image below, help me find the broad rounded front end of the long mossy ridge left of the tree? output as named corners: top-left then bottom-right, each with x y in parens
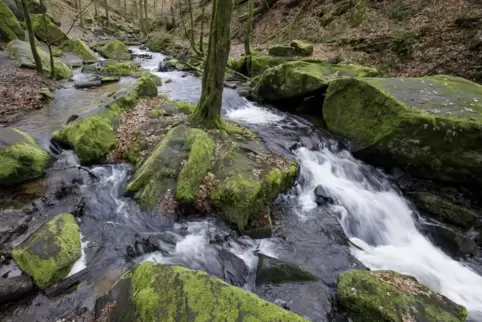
top-left (52, 115), bottom-right (116, 164)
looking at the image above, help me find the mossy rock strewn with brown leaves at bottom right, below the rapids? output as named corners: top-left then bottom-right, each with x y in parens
top-left (337, 270), bottom-right (467, 322)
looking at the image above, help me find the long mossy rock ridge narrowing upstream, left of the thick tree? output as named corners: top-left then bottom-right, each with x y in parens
top-left (52, 73), bottom-right (157, 164)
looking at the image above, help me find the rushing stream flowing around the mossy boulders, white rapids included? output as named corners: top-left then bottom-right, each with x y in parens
top-left (0, 47), bottom-right (482, 321)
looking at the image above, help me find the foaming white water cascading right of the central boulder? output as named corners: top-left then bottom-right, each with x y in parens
top-left (227, 105), bottom-right (482, 321)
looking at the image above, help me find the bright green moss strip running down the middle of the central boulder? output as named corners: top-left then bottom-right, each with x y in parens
top-left (176, 129), bottom-right (214, 205)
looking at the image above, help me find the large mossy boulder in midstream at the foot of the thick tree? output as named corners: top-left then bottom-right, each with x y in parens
top-left (127, 121), bottom-right (298, 231)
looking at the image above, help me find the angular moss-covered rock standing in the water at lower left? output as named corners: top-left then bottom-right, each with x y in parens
top-left (12, 214), bottom-right (81, 288)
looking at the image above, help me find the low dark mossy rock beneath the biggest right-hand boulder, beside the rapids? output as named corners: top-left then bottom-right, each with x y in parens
top-left (414, 192), bottom-right (478, 228)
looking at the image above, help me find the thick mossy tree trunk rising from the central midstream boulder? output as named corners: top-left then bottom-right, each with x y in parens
top-left (191, 0), bottom-right (233, 128)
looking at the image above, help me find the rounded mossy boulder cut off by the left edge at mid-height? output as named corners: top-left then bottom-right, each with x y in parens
top-left (0, 127), bottom-right (49, 185)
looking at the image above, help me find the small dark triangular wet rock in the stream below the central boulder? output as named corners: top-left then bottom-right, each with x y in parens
top-left (256, 254), bottom-right (318, 285)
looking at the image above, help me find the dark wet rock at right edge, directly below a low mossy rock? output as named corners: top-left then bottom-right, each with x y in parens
top-left (425, 225), bottom-right (479, 257)
